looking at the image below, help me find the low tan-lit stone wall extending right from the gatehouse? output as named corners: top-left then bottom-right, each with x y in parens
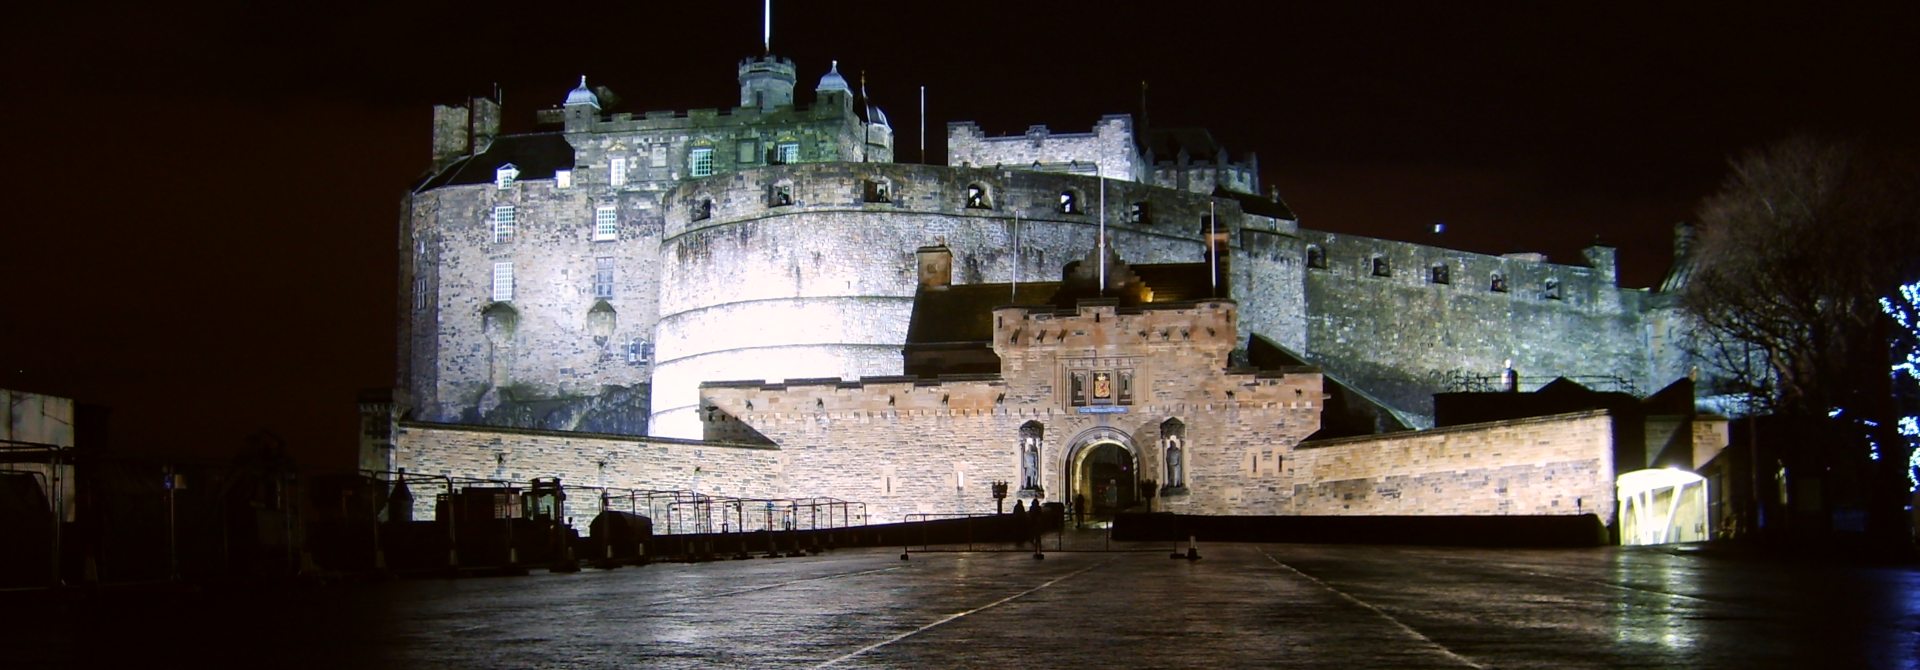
top-left (1269, 411), bottom-right (1615, 524)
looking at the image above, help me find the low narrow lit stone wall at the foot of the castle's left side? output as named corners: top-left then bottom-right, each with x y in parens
top-left (394, 422), bottom-right (787, 528)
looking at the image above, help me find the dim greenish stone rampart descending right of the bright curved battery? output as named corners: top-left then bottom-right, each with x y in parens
top-left (1300, 230), bottom-right (1665, 420)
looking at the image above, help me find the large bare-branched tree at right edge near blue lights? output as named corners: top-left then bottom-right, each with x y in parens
top-left (1680, 136), bottom-right (1920, 538)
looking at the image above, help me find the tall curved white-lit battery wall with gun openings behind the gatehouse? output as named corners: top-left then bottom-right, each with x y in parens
top-left (653, 163), bottom-right (1274, 438)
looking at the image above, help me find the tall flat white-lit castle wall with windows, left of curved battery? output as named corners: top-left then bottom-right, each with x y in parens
top-left (403, 180), bottom-right (660, 432)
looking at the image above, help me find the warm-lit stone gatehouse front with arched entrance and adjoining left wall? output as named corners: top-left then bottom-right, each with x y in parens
top-left (701, 301), bottom-right (1321, 520)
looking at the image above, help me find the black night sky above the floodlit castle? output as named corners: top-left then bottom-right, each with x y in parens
top-left (0, 0), bottom-right (1920, 468)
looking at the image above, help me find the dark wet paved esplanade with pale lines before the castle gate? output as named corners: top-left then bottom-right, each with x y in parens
top-left (0, 541), bottom-right (1920, 670)
